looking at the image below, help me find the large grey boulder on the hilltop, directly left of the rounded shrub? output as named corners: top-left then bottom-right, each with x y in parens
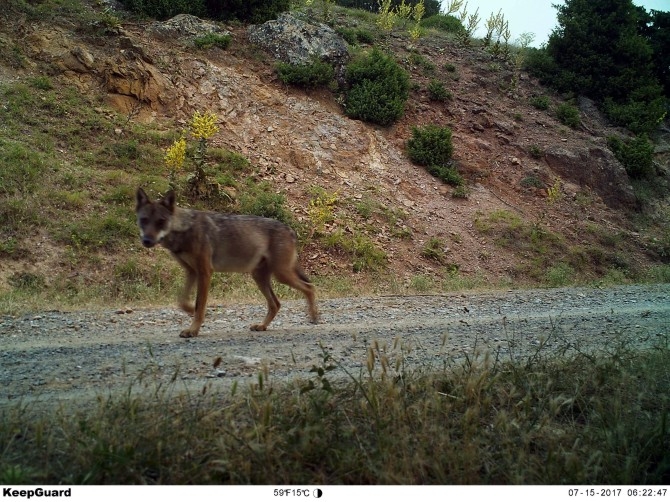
top-left (248, 12), bottom-right (349, 69)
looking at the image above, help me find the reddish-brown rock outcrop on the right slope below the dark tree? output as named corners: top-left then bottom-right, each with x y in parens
top-left (545, 145), bottom-right (637, 209)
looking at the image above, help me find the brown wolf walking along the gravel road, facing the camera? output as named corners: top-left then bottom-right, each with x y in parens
top-left (135, 188), bottom-right (318, 338)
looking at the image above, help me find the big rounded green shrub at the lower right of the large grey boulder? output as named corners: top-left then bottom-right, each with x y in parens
top-left (344, 48), bottom-right (409, 126)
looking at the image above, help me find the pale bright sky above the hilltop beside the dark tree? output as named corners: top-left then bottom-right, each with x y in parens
top-left (442, 0), bottom-right (670, 47)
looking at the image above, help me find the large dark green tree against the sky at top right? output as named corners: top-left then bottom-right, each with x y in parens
top-left (525, 0), bottom-right (670, 134)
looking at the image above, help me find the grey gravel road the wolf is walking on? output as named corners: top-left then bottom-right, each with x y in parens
top-left (0, 284), bottom-right (670, 406)
